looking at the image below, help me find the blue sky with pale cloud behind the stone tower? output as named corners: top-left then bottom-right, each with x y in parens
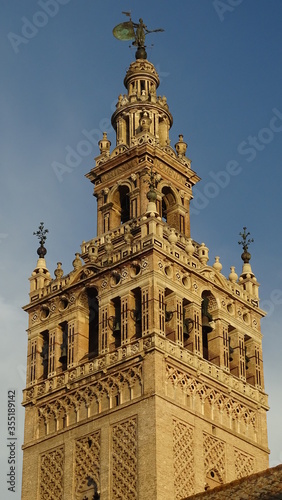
top-left (0, 0), bottom-right (282, 492)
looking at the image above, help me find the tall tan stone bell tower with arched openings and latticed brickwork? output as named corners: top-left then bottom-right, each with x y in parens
top-left (22, 19), bottom-right (269, 500)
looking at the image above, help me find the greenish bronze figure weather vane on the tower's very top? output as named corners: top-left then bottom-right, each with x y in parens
top-left (113, 12), bottom-right (164, 59)
